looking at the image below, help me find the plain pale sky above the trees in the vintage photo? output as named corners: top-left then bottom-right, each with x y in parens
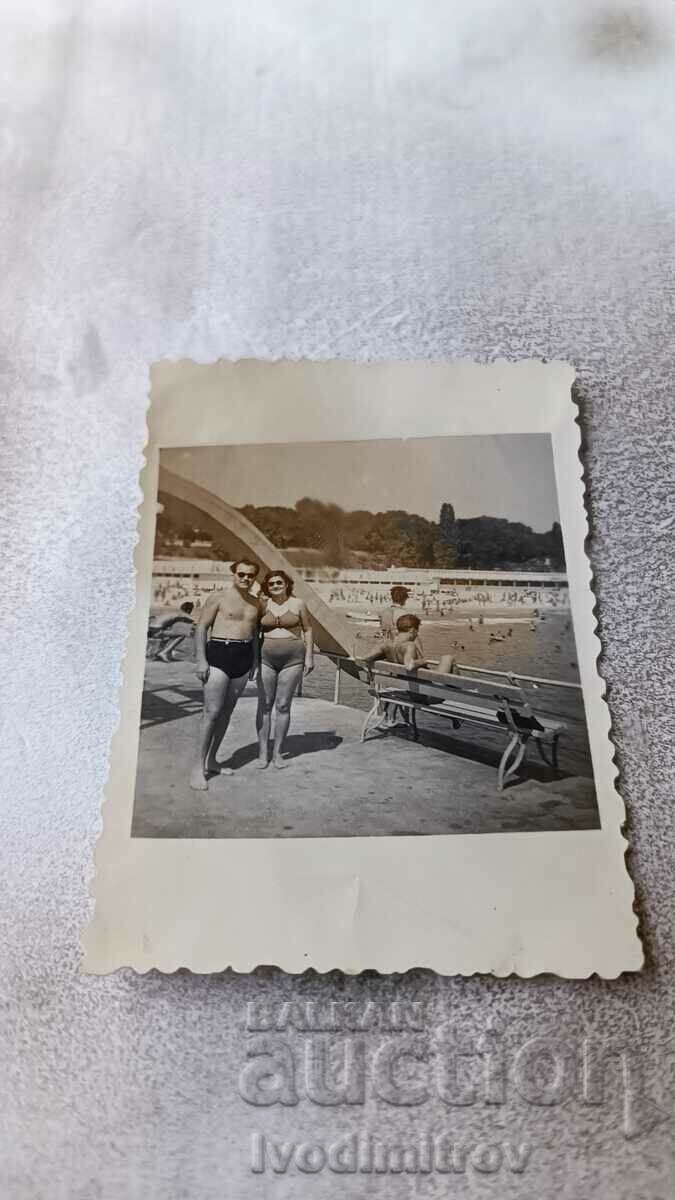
top-left (161, 433), bottom-right (558, 532)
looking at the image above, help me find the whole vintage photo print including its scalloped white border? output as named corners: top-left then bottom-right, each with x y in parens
top-left (85, 360), bottom-right (641, 976)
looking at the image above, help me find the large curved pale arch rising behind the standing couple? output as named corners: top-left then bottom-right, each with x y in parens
top-left (159, 467), bottom-right (357, 673)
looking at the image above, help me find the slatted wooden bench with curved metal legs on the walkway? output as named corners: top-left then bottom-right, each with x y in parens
top-left (362, 660), bottom-right (566, 792)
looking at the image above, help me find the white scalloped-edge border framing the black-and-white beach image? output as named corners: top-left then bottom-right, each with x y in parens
top-left (83, 360), bottom-right (643, 978)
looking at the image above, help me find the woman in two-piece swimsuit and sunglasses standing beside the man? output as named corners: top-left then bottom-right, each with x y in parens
top-left (257, 571), bottom-right (313, 767)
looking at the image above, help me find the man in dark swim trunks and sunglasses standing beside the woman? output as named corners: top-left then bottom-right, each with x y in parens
top-left (190, 559), bottom-right (261, 792)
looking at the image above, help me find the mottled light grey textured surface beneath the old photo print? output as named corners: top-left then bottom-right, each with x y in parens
top-left (0, 0), bottom-right (675, 1200)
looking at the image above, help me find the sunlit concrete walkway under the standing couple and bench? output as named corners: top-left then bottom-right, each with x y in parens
top-left (132, 662), bottom-right (598, 838)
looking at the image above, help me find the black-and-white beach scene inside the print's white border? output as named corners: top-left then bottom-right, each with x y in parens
top-left (132, 433), bottom-right (599, 838)
